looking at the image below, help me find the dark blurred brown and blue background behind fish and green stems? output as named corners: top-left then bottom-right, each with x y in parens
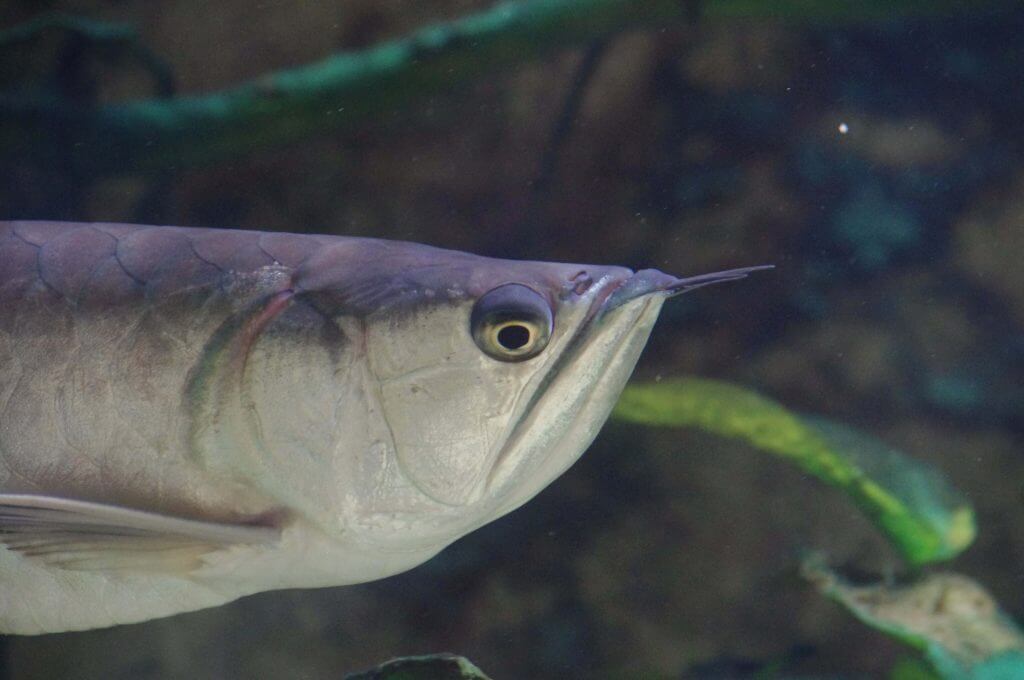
top-left (0, 0), bottom-right (1024, 680)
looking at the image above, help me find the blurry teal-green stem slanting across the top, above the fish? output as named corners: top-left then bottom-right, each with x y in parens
top-left (0, 0), bottom-right (990, 176)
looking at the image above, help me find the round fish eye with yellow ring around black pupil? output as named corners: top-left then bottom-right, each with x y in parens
top-left (469, 284), bottom-right (554, 362)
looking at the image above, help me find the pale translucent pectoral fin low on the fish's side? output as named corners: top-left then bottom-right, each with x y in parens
top-left (0, 494), bottom-right (280, 572)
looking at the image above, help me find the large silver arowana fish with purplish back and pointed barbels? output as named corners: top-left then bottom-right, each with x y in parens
top-left (0, 222), bottom-right (770, 634)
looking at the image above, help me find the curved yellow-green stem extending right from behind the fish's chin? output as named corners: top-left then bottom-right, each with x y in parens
top-left (612, 378), bottom-right (976, 565)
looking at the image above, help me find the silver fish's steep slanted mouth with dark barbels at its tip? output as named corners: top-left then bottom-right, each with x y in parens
top-left (484, 264), bottom-right (774, 499)
